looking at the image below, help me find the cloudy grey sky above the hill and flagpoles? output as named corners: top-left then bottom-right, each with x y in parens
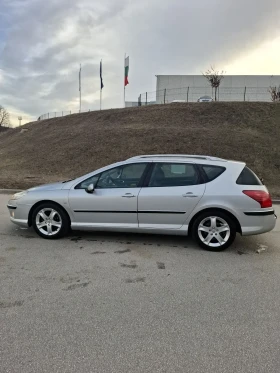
top-left (0, 0), bottom-right (280, 125)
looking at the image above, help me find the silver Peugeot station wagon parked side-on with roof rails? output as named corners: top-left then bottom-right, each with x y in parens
top-left (8, 154), bottom-right (276, 251)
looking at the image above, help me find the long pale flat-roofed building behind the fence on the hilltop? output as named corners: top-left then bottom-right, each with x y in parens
top-left (156, 75), bottom-right (280, 104)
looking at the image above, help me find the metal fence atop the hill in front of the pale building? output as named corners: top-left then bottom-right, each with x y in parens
top-left (138, 86), bottom-right (272, 106)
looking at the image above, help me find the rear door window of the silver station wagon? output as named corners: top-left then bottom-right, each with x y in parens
top-left (148, 163), bottom-right (199, 187)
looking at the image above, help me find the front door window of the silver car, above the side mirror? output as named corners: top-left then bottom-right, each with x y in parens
top-left (76, 163), bottom-right (147, 189)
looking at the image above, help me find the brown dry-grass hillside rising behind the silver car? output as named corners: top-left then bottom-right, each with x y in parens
top-left (0, 102), bottom-right (280, 196)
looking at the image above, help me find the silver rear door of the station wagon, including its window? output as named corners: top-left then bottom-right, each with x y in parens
top-left (138, 162), bottom-right (205, 229)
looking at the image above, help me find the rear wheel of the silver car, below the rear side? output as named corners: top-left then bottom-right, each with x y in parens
top-left (192, 210), bottom-right (236, 251)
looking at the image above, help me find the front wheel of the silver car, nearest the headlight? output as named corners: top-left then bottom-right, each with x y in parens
top-left (32, 202), bottom-right (70, 240)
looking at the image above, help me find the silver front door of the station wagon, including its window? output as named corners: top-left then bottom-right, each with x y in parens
top-left (69, 163), bottom-right (147, 228)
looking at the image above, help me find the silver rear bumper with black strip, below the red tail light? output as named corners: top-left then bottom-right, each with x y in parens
top-left (241, 210), bottom-right (277, 236)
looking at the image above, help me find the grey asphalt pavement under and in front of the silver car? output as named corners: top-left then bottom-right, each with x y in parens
top-left (0, 195), bottom-right (280, 373)
